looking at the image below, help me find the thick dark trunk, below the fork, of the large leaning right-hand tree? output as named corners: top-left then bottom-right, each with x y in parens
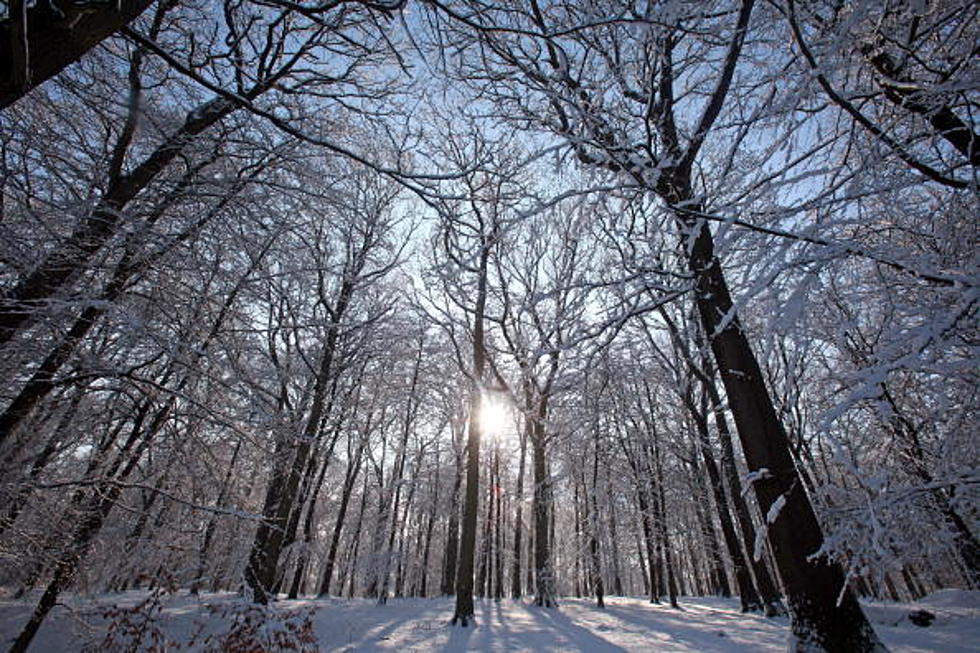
top-left (661, 186), bottom-right (884, 652)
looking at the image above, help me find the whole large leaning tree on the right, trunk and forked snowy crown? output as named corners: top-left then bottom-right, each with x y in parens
top-left (424, 0), bottom-right (881, 651)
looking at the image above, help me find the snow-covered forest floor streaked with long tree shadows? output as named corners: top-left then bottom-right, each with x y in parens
top-left (0, 590), bottom-right (980, 653)
